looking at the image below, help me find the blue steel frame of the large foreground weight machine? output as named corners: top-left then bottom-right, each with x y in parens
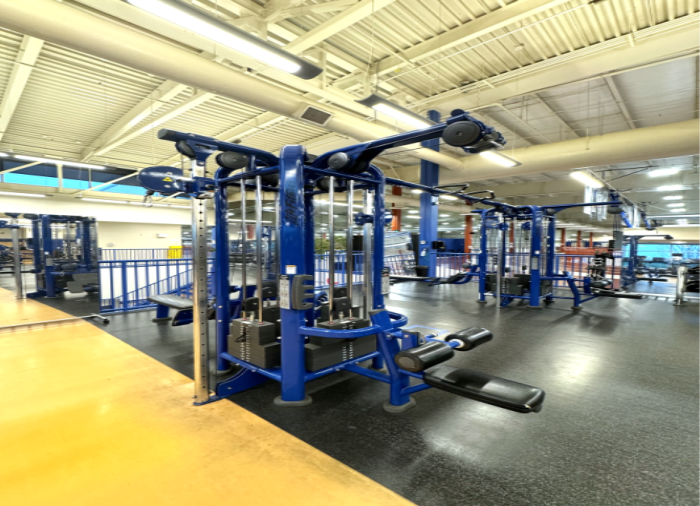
top-left (141, 111), bottom-right (512, 406)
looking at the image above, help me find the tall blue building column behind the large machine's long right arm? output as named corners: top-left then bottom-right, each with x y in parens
top-left (418, 111), bottom-right (440, 277)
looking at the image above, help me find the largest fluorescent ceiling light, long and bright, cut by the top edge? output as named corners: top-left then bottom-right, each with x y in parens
top-left (127, 0), bottom-right (323, 79)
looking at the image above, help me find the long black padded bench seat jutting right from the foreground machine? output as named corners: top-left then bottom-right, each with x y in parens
top-left (423, 365), bottom-right (544, 413)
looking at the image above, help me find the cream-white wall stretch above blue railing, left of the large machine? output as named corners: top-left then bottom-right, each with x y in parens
top-left (97, 221), bottom-right (182, 249)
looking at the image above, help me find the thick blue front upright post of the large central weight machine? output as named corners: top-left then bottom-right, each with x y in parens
top-left (275, 146), bottom-right (313, 406)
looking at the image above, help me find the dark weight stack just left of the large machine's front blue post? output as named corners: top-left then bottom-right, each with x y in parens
top-left (228, 318), bottom-right (281, 369)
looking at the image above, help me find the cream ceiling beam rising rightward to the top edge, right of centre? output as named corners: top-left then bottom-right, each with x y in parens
top-left (377, 0), bottom-right (569, 75)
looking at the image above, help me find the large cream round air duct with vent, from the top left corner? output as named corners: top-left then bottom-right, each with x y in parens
top-left (0, 0), bottom-right (464, 170)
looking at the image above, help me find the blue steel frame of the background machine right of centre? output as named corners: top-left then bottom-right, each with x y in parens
top-left (474, 201), bottom-right (621, 309)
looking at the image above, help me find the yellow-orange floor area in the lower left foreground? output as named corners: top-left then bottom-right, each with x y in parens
top-left (0, 290), bottom-right (412, 506)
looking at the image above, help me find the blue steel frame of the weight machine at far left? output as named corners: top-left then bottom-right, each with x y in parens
top-left (27, 214), bottom-right (99, 298)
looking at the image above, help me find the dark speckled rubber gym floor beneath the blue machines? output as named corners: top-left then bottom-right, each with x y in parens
top-left (100, 283), bottom-right (700, 506)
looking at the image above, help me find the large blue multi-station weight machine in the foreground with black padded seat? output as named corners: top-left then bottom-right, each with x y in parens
top-left (139, 110), bottom-right (544, 413)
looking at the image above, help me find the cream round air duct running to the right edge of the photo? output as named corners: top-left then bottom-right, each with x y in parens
top-left (440, 119), bottom-right (700, 184)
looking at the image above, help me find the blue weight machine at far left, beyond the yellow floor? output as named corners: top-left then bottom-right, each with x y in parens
top-left (24, 214), bottom-right (99, 298)
